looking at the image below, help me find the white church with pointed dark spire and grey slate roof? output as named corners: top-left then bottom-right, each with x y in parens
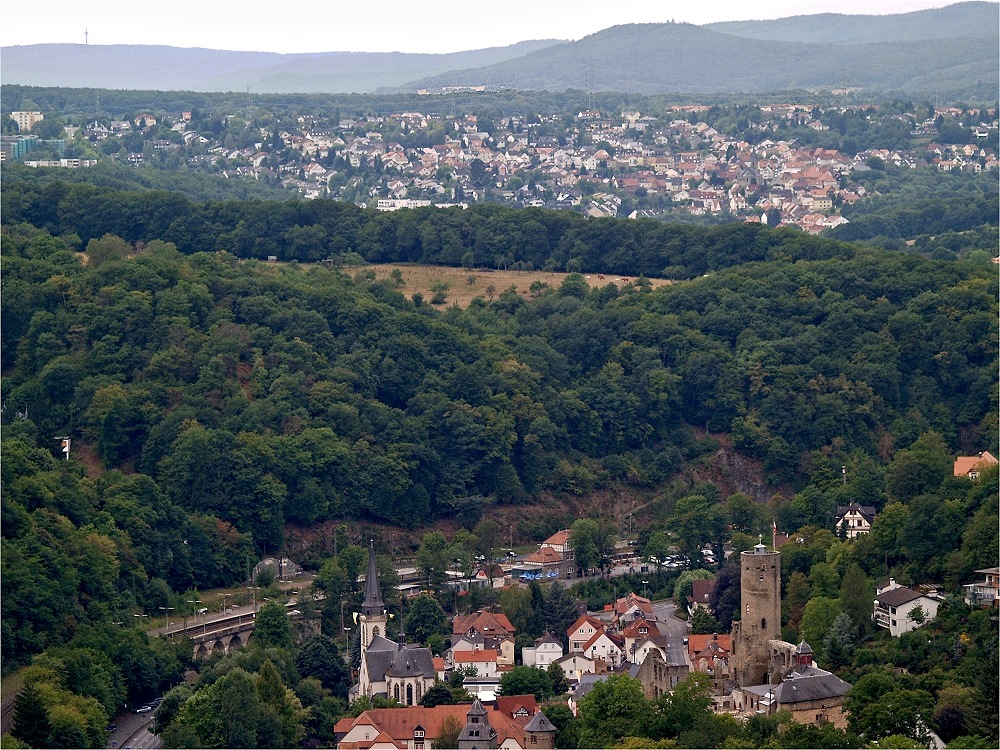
top-left (350, 542), bottom-right (436, 706)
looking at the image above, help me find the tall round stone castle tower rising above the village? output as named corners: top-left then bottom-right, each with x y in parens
top-left (731, 544), bottom-right (781, 687)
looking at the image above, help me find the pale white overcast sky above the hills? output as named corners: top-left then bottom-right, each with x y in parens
top-left (0, 0), bottom-right (968, 52)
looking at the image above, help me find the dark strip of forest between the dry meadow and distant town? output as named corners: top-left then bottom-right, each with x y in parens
top-left (3, 181), bottom-right (854, 279)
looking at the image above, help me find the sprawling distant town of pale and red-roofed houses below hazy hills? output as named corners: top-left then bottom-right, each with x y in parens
top-left (2, 103), bottom-right (998, 234)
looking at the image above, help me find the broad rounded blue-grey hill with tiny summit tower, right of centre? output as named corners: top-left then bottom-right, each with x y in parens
top-left (407, 24), bottom-right (1000, 99)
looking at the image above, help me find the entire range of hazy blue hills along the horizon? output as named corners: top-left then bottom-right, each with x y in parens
top-left (0, 2), bottom-right (1000, 101)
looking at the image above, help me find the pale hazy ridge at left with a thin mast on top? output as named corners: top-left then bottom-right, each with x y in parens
top-left (0, 40), bottom-right (559, 94)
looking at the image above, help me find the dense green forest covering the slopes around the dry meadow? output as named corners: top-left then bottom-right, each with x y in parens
top-left (0, 175), bottom-right (998, 746)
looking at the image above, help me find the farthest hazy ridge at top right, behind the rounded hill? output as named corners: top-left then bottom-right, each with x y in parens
top-left (704, 2), bottom-right (1000, 44)
